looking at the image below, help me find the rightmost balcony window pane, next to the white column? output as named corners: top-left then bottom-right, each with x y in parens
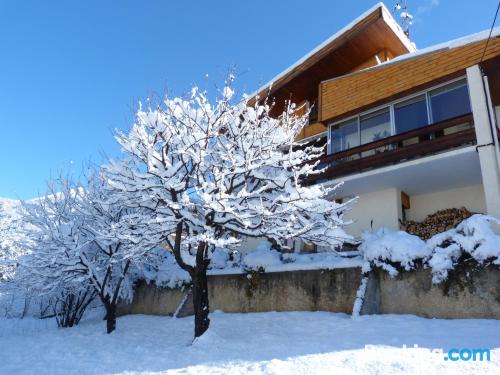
top-left (429, 80), bottom-right (471, 123)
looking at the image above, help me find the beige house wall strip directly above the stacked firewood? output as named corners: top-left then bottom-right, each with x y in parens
top-left (406, 185), bottom-right (486, 221)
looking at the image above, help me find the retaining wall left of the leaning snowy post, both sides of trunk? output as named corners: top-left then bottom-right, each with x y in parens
top-left (118, 268), bottom-right (361, 316)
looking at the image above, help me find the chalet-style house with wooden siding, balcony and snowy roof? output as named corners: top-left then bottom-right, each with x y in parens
top-left (254, 3), bottom-right (500, 244)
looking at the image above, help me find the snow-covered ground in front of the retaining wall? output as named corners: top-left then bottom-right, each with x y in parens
top-left (0, 312), bottom-right (500, 375)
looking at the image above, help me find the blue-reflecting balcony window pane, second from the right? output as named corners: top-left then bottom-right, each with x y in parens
top-left (394, 94), bottom-right (429, 134)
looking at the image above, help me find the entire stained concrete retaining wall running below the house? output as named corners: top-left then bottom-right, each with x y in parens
top-left (119, 268), bottom-right (500, 319)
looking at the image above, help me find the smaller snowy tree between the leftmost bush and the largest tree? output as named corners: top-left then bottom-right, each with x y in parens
top-left (78, 174), bottom-right (160, 333)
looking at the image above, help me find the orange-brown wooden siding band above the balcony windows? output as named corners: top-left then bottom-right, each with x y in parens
top-left (319, 37), bottom-right (500, 122)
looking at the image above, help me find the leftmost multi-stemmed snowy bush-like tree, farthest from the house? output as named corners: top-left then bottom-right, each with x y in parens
top-left (19, 178), bottom-right (96, 327)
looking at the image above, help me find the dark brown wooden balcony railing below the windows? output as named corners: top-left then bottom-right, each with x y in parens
top-left (305, 113), bottom-right (476, 184)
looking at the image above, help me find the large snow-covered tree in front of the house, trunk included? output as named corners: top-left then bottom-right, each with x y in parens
top-left (105, 77), bottom-right (349, 337)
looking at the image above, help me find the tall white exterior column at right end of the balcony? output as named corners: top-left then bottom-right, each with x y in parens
top-left (467, 65), bottom-right (500, 218)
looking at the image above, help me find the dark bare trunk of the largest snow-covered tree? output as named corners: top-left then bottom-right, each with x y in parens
top-left (192, 243), bottom-right (210, 338)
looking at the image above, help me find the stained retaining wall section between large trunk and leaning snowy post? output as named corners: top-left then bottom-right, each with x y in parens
top-left (209, 268), bottom-right (361, 314)
